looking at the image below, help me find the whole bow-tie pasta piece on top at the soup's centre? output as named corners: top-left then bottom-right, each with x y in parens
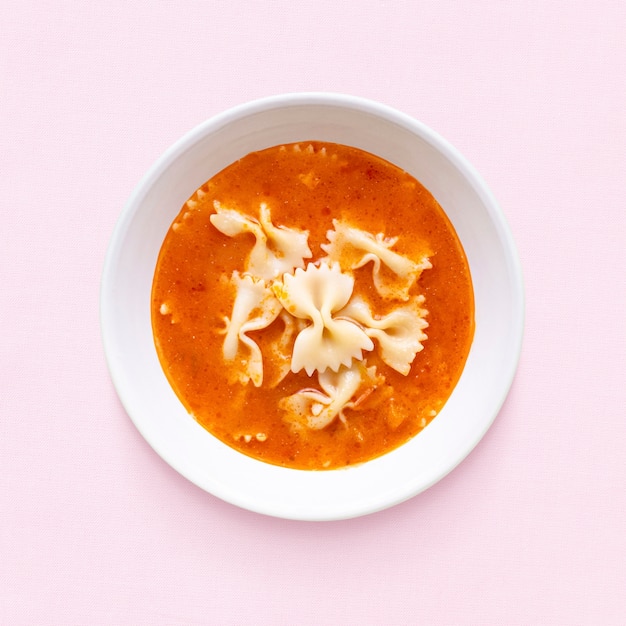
top-left (274, 263), bottom-right (374, 376)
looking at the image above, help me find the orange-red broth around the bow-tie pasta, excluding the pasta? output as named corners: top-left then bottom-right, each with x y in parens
top-left (151, 141), bottom-right (474, 470)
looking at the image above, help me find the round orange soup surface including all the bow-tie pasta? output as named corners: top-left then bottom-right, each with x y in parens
top-left (151, 141), bottom-right (474, 470)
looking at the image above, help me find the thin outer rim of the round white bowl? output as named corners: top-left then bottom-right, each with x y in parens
top-left (99, 92), bottom-right (525, 521)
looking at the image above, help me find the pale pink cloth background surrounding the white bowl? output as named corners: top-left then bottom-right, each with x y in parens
top-left (0, 0), bottom-right (626, 625)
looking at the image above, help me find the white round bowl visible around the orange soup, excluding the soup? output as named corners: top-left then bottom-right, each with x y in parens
top-left (101, 93), bottom-right (524, 520)
